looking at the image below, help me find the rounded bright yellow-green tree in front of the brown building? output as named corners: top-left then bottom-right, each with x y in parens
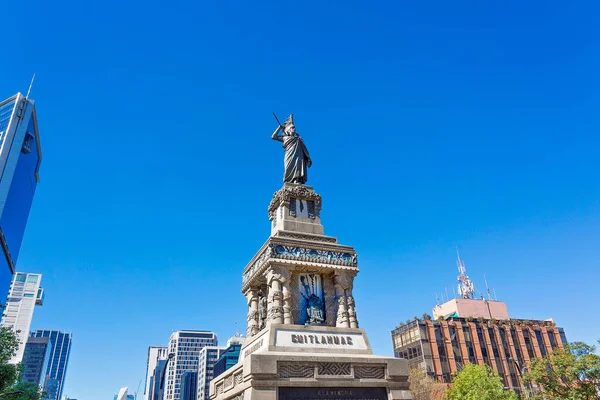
top-left (446, 364), bottom-right (518, 400)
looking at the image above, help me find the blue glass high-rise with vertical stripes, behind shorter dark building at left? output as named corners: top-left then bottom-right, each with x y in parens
top-left (31, 330), bottom-right (73, 400)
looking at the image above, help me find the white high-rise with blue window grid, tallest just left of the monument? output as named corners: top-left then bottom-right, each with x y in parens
top-left (165, 331), bottom-right (218, 400)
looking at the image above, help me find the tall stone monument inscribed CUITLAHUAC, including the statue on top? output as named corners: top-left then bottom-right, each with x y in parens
top-left (210, 116), bottom-right (411, 400)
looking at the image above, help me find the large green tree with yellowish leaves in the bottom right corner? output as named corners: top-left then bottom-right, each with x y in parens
top-left (523, 342), bottom-right (600, 400)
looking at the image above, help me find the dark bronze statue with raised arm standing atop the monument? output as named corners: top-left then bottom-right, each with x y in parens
top-left (271, 114), bottom-right (312, 184)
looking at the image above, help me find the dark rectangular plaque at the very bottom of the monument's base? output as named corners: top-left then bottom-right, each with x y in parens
top-left (278, 387), bottom-right (387, 400)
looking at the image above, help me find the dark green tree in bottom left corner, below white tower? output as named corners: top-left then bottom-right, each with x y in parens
top-left (0, 305), bottom-right (43, 400)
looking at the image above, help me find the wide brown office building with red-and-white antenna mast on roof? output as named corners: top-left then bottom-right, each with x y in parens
top-left (392, 253), bottom-right (567, 392)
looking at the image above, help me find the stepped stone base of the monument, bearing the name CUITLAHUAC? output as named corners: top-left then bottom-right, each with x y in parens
top-left (210, 324), bottom-right (412, 400)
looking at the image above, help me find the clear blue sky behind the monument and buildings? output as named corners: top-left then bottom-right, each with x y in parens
top-left (0, 0), bottom-right (600, 400)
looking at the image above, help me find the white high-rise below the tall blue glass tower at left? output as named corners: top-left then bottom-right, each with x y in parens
top-left (1, 272), bottom-right (44, 364)
